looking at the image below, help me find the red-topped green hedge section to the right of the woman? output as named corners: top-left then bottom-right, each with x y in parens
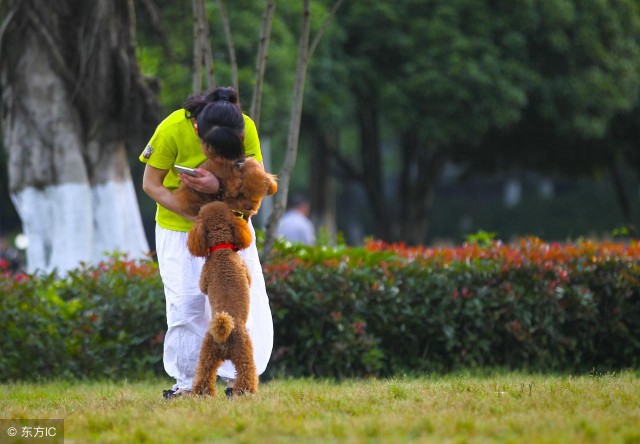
top-left (265, 239), bottom-right (640, 377)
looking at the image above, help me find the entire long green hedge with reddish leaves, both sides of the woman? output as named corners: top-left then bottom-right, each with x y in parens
top-left (0, 239), bottom-right (640, 381)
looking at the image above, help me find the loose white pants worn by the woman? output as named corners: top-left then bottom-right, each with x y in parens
top-left (156, 222), bottom-right (273, 390)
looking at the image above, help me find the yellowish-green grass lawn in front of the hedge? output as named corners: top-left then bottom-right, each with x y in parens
top-left (0, 372), bottom-right (640, 444)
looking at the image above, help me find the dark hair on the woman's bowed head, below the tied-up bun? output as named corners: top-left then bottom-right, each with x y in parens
top-left (196, 100), bottom-right (244, 159)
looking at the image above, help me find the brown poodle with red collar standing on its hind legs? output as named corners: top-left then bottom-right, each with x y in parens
top-left (187, 202), bottom-right (258, 395)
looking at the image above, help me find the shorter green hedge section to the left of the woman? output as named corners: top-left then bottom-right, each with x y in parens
top-left (0, 257), bottom-right (166, 381)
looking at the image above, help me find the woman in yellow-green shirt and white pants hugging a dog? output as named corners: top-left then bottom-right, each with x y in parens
top-left (140, 88), bottom-right (273, 399)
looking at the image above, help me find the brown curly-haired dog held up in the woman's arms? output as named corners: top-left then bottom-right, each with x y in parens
top-left (174, 157), bottom-right (278, 218)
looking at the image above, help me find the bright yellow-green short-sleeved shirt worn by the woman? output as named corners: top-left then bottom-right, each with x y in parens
top-left (139, 109), bottom-right (262, 231)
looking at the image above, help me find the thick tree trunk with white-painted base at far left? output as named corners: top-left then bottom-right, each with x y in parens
top-left (0, 0), bottom-right (159, 273)
